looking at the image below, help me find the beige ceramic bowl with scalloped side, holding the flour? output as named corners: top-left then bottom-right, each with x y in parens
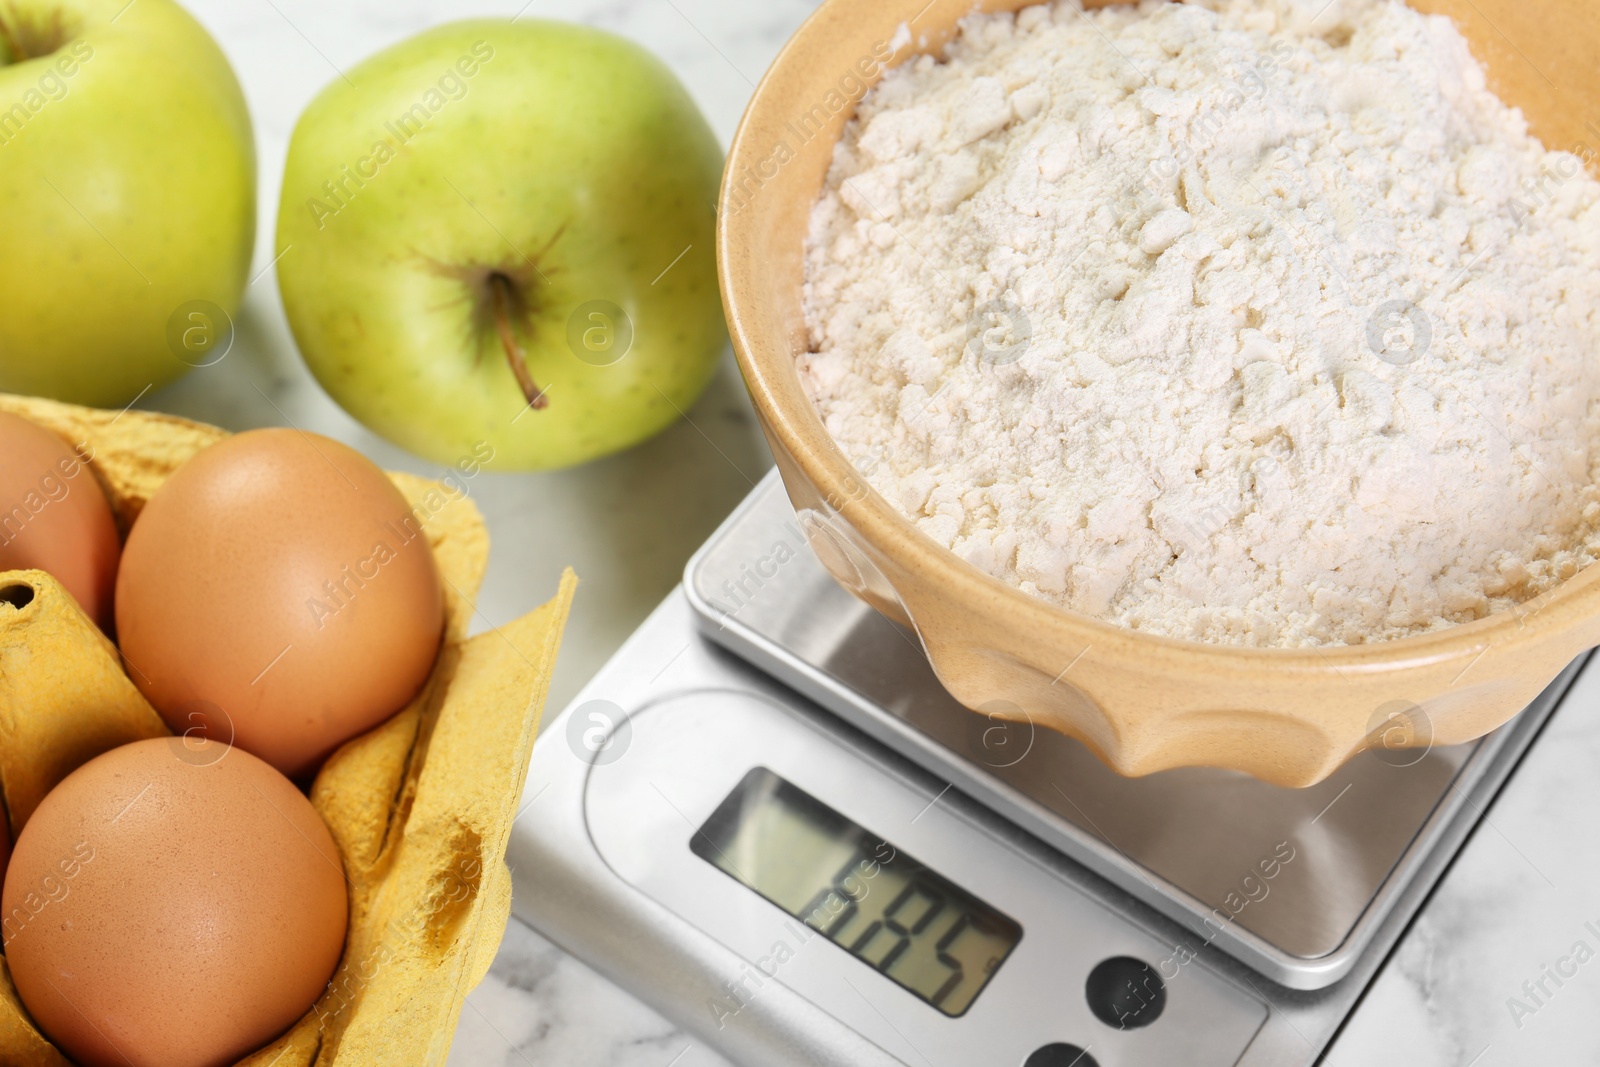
top-left (718, 0), bottom-right (1600, 785)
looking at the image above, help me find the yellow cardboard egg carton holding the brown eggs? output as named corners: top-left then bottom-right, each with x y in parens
top-left (0, 394), bottom-right (578, 1067)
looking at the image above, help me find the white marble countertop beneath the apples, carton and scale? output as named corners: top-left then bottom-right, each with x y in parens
top-left (159, 0), bottom-right (1600, 1067)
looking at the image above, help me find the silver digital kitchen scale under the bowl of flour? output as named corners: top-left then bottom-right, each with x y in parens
top-left (507, 474), bottom-right (1582, 1067)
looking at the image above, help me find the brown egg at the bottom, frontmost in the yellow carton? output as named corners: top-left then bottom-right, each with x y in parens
top-left (0, 737), bottom-right (349, 1067)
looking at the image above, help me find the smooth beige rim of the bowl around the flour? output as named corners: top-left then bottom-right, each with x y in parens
top-left (717, 0), bottom-right (1600, 675)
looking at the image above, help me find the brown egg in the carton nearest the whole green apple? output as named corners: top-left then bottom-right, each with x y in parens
top-left (117, 430), bottom-right (445, 776)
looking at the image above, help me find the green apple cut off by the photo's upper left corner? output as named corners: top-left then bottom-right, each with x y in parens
top-left (0, 0), bottom-right (256, 406)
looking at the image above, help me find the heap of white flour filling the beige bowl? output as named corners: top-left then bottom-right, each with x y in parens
top-left (800, 0), bottom-right (1600, 646)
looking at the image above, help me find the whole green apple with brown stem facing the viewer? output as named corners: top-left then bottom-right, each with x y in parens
top-left (277, 19), bottom-right (726, 470)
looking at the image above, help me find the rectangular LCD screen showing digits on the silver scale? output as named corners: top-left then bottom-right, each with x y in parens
top-left (690, 766), bottom-right (1022, 1016)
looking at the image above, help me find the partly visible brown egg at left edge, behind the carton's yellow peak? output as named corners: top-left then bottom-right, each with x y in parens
top-left (0, 411), bottom-right (122, 630)
